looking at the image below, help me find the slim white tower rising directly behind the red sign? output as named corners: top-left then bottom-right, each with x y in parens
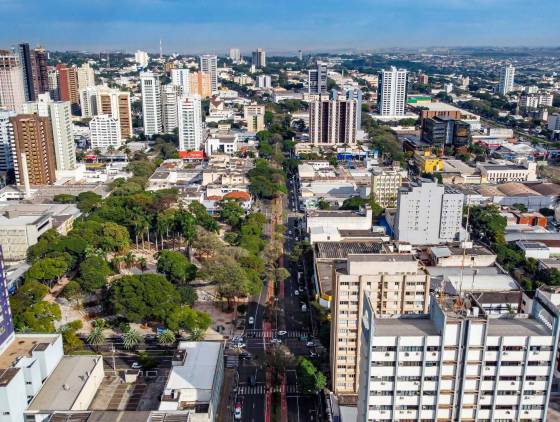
top-left (177, 95), bottom-right (203, 151)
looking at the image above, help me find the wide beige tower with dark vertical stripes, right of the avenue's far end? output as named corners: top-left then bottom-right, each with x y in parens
top-left (309, 95), bottom-right (357, 146)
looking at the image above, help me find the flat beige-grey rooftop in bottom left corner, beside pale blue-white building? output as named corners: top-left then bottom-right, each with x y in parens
top-left (27, 355), bottom-right (101, 411)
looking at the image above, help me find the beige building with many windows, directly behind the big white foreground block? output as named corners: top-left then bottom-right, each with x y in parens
top-left (330, 253), bottom-right (430, 398)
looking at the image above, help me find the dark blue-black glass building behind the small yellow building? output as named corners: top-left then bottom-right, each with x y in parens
top-left (422, 116), bottom-right (471, 147)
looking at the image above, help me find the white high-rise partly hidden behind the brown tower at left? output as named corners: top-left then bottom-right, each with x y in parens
top-left (23, 93), bottom-right (76, 171)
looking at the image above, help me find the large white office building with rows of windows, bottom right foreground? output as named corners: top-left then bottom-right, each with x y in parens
top-left (357, 291), bottom-right (560, 422)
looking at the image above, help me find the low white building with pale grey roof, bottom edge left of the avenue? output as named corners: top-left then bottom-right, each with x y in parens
top-left (159, 341), bottom-right (224, 422)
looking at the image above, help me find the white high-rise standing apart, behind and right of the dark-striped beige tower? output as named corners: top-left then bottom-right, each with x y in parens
top-left (377, 66), bottom-right (408, 116)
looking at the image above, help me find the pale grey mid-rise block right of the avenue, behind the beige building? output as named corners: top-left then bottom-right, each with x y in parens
top-left (394, 179), bottom-right (464, 245)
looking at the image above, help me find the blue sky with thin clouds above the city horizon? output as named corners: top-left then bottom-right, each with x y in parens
top-left (0, 0), bottom-right (560, 53)
